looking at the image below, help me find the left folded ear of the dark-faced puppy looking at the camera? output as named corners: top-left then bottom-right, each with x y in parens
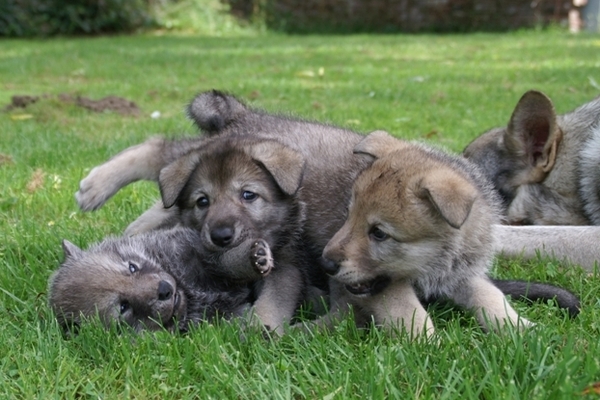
top-left (158, 152), bottom-right (200, 208)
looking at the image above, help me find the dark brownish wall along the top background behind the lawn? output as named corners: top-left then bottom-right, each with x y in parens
top-left (223, 0), bottom-right (571, 33)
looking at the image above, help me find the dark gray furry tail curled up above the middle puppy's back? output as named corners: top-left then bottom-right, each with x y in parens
top-left (187, 90), bottom-right (247, 135)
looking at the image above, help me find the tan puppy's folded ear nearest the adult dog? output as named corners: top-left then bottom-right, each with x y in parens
top-left (417, 170), bottom-right (479, 229)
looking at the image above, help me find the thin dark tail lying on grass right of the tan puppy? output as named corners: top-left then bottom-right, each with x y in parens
top-left (492, 279), bottom-right (581, 318)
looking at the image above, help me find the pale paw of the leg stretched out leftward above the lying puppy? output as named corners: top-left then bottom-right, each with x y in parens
top-left (75, 165), bottom-right (121, 211)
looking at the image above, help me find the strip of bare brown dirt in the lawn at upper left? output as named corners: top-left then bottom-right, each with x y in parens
top-left (4, 94), bottom-right (141, 116)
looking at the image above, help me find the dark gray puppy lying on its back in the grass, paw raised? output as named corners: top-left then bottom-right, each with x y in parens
top-left (49, 227), bottom-right (273, 331)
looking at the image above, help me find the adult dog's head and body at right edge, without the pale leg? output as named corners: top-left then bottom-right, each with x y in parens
top-left (464, 90), bottom-right (600, 225)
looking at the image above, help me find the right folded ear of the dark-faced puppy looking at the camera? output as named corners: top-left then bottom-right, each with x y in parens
top-left (245, 140), bottom-right (305, 195)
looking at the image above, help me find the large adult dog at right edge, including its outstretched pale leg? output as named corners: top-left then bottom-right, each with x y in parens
top-left (464, 91), bottom-right (600, 270)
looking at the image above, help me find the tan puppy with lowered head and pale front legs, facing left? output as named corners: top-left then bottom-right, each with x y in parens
top-left (323, 131), bottom-right (531, 335)
